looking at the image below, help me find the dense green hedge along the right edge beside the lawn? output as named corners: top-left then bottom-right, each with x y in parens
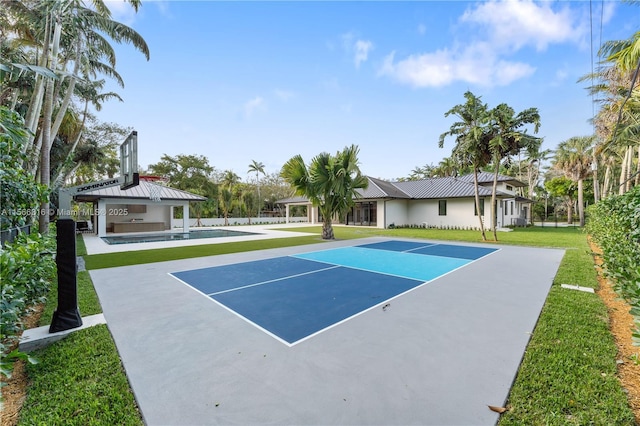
top-left (587, 187), bottom-right (640, 345)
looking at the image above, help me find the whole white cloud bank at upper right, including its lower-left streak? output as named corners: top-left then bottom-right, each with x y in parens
top-left (378, 0), bottom-right (592, 87)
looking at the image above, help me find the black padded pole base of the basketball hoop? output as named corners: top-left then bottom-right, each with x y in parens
top-left (49, 219), bottom-right (82, 333)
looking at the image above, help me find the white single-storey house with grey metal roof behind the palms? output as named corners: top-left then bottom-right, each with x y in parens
top-left (279, 172), bottom-right (532, 228)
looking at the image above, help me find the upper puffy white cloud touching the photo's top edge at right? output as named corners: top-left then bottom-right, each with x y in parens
top-left (460, 0), bottom-right (585, 51)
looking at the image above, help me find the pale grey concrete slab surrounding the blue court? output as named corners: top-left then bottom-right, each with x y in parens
top-left (87, 231), bottom-right (564, 425)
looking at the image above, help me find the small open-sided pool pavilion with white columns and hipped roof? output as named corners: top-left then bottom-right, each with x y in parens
top-left (74, 176), bottom-right (206, 237)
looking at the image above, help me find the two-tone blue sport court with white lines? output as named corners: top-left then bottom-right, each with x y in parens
top-left (170, 240), bottom-right (497, 346)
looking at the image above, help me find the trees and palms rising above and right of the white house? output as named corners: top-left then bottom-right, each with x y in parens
top-left (408, 20), bottom-right (640, 231)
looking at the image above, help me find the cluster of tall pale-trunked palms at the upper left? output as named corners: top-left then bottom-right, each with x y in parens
top-left (3, 0), bottom-right (149, 232)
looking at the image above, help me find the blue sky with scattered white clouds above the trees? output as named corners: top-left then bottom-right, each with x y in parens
top-left (98, 1), bottom-right (640, 180)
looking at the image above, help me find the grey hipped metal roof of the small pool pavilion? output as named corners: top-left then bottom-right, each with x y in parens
top-left (74, 180), bottom-right (206, 202)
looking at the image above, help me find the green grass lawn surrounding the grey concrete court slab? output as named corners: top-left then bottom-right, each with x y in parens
top-left (20, 226), bottom-right (634, 425)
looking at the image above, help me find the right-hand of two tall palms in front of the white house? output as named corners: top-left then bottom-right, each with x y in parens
top-left (489, 103), bottom-right (542, 241)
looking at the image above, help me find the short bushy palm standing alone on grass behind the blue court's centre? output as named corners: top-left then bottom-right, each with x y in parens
top-left (281, 145), bottom-right (369, 240)
